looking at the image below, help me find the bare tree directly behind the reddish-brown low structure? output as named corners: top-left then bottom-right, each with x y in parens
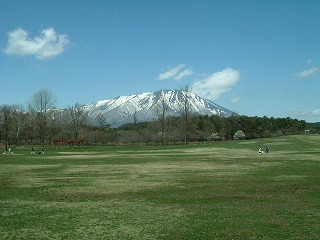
top-left (68, 103), bottom-right (88, 138)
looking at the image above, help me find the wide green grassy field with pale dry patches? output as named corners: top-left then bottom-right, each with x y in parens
top-left (0, 135), bottom-right (320, 239)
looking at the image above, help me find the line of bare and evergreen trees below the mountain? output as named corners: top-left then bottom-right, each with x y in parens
top-left (0, 88), bottom-right (320, 149)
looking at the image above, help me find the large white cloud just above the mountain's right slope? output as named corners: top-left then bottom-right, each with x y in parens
top-left (192, 68), bottom-right (240, 100)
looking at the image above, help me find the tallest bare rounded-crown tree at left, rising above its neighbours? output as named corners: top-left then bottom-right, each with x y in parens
top-left (29, 89), bottom-right (56, 146)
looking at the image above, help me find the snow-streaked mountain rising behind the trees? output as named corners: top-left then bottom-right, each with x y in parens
top-left (85, 90), bottom-right (235, 127)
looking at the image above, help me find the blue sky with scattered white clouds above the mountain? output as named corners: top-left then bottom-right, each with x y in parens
top-left (0, 0), bottom-right (320, 122)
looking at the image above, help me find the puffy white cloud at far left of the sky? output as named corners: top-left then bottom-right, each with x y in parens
top-left (4, 28), bottom-right (70, 59)
